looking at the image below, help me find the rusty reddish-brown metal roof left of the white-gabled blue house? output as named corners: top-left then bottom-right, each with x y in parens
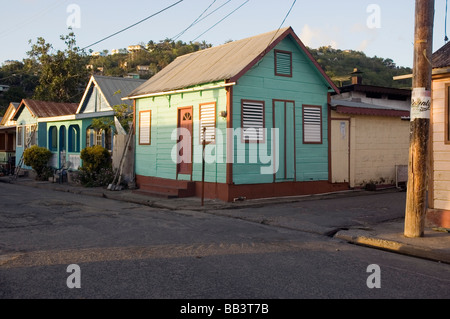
top-left (13, 99), bottom-right (78, 120)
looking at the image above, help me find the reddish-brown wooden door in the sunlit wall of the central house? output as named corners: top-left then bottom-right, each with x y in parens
top-left (177, 107), bottom-right (193, 175)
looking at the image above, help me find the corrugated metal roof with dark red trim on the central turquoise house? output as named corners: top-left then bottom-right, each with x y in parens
top-left (126, 27), bottom-right (338, 97)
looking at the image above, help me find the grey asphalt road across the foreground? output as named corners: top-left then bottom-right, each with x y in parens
top-left (0, 184), bottom-right (450, 302)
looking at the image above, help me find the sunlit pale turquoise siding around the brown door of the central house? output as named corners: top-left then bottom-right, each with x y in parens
top-left (135, 83), bottom-right (227, 183)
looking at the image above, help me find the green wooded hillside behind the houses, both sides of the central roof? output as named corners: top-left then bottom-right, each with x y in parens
top-left (0, 35), bottom-right (412, 116)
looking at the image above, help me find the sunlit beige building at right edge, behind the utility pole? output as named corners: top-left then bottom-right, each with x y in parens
top-left (427, 43), bottom-right (450, 228)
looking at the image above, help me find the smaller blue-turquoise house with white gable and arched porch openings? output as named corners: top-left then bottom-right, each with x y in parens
top-left (41, 75), bottom-right (145, 170)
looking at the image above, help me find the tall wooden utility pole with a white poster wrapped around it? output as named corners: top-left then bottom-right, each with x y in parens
top-left (404, 0), bottom-right (434, 237)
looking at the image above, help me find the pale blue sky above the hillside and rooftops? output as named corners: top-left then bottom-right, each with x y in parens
top-left (0, 0), bottom-right (450, 72)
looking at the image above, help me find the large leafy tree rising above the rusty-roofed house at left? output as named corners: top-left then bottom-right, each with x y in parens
top-left (24, 32), bottom-right (89, 102)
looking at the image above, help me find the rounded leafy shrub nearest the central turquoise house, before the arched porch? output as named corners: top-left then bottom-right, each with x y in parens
top-left (77, 145), bottom-right (115, 187)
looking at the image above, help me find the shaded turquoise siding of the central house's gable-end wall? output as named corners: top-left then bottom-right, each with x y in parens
top-left (233, 37), bottom-right (328, 184)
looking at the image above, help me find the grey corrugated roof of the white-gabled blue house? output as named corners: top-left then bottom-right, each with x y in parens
top-left (93, 75), bottom-right (146, 107)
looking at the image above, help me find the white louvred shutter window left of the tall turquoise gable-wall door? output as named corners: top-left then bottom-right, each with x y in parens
top-left (242, 101), bottom-right (264, 142)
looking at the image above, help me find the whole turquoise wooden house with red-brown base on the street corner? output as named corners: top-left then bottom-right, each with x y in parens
top-left (127, 27), bottom-right (342, 201)
